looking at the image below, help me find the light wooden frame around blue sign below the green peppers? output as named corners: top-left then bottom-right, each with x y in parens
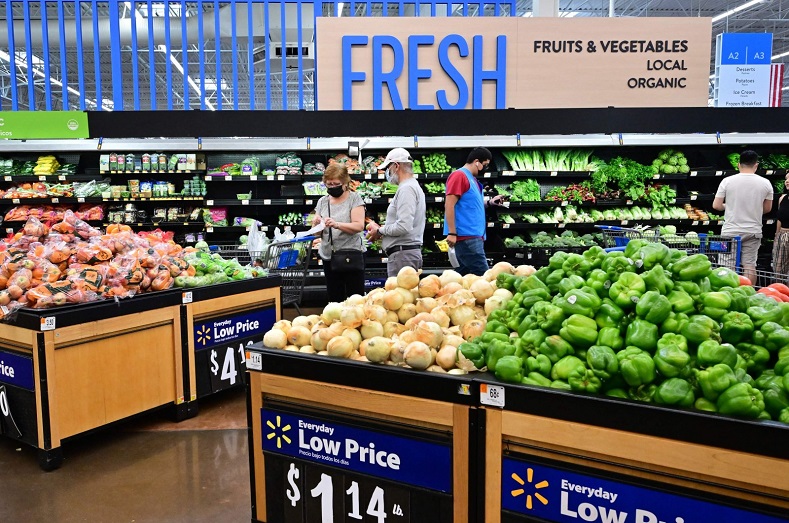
top-left (485, 408), bottom-right (789, 523)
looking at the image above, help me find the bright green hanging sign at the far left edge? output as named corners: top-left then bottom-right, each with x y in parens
top-left (0, 111), bottom-right (89, 140)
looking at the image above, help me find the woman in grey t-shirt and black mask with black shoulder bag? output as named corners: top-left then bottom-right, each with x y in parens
top-left (312, 163), bottom-right (365, 302)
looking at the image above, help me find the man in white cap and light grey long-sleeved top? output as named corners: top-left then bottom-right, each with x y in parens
top-left (367, 147), bottom-right (427, 276)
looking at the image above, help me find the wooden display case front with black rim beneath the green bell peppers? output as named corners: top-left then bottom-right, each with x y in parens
top-left (478, 374), bottom-right (789, 523)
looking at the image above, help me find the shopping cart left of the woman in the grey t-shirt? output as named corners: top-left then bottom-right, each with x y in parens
top-left (254, 236), bottom-right (315, 315)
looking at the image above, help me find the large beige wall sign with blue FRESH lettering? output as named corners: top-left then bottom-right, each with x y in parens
top-left (317, 17), bottom-right (712, 110)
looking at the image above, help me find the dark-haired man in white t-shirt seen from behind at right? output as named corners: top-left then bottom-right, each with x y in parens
top-left (712, 151), bottom-right (773, 284)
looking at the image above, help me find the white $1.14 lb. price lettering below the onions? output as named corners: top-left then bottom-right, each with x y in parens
top-left (285, 463), bottom-right (408, 523)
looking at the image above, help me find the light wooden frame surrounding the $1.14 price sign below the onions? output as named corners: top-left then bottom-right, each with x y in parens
top-left (249, 372), bottom-right (473, 523)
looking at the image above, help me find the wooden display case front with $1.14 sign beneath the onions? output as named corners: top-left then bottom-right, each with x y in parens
top-left (247, 344), bottom-right (481, 523)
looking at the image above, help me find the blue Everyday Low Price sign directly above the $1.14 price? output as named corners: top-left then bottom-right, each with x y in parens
top-left (260, 408), bottom-right (452, 492)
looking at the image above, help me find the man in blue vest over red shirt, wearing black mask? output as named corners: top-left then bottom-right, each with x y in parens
top-left (444, 147), bottom-right (502, 276)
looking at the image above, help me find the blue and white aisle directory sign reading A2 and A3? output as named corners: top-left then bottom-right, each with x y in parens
top-left (715, 33), bottom-right (780, 107)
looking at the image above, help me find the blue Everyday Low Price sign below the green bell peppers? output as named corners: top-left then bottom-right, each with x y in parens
top-left (501, 457), bottom-right (785, 523)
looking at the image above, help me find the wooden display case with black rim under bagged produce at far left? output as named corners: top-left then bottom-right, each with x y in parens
top-left (0, 291), bottom-right (184, 470)
